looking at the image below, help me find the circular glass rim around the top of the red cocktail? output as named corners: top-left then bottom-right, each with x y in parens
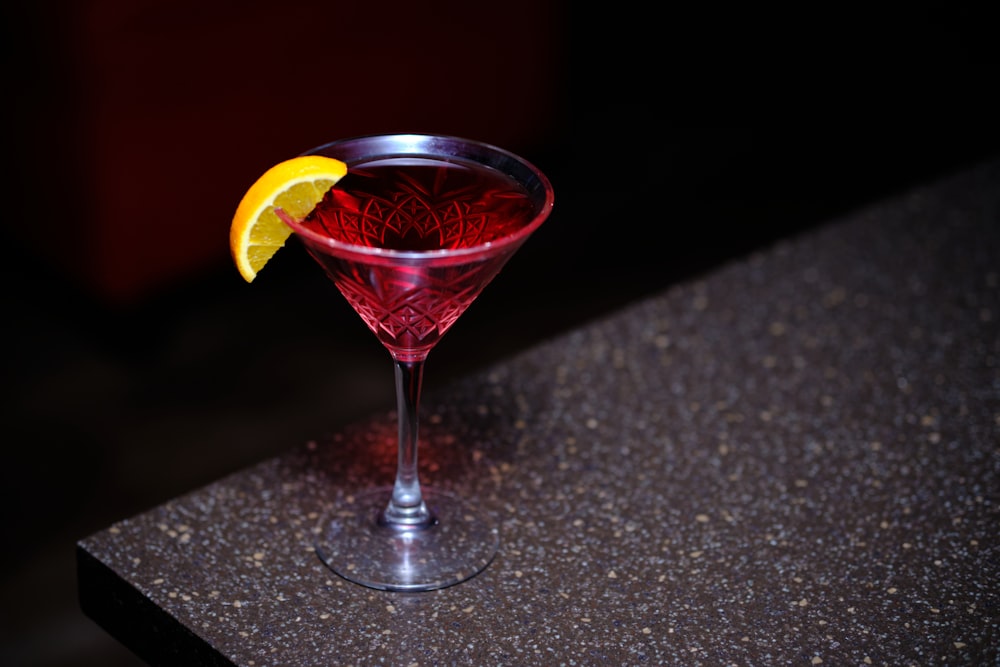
top-left (285, 133), bottom-right (555, 263)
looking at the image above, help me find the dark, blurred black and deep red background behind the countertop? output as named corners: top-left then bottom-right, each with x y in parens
top-left (0, 0), bottom-right (1000, 665)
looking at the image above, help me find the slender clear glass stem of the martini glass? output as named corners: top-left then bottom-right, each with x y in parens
top-left (379, 359), bottom-right (436, 530)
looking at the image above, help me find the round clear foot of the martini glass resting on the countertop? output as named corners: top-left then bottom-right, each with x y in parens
top-left (316, 487), bottom-right (500, 591)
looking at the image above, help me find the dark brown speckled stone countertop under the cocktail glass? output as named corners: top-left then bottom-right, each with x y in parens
top-left (78, 164), bottom-right (1000, 667)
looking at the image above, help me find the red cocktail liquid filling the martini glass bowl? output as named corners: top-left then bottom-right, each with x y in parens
top-left (303, 157), bottom-right (537, 359)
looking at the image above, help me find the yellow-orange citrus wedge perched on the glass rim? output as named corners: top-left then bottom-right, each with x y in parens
top-left (229, 155), bottom-right (347, 282)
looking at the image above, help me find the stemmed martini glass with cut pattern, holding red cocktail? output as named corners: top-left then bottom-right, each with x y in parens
top-left (282, 134), bottom-right (553, 591)
